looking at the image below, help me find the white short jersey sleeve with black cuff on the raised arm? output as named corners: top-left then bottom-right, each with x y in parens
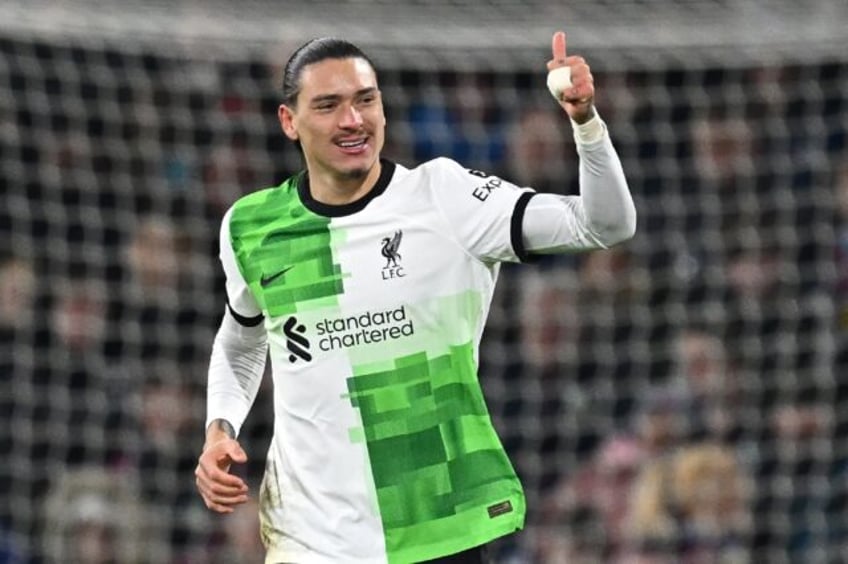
top-left (433, 159), bottom-right (535, 262)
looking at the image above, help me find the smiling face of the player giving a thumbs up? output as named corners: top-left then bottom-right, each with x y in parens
top-left (278, 58), bottom-right (386, 179)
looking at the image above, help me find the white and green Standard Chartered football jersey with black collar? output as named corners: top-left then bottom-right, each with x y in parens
top-left (222, 159), bottom-right (533, 563)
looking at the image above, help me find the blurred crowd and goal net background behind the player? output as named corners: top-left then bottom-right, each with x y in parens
top-left (0, 0), bottom-right (848, 563)
